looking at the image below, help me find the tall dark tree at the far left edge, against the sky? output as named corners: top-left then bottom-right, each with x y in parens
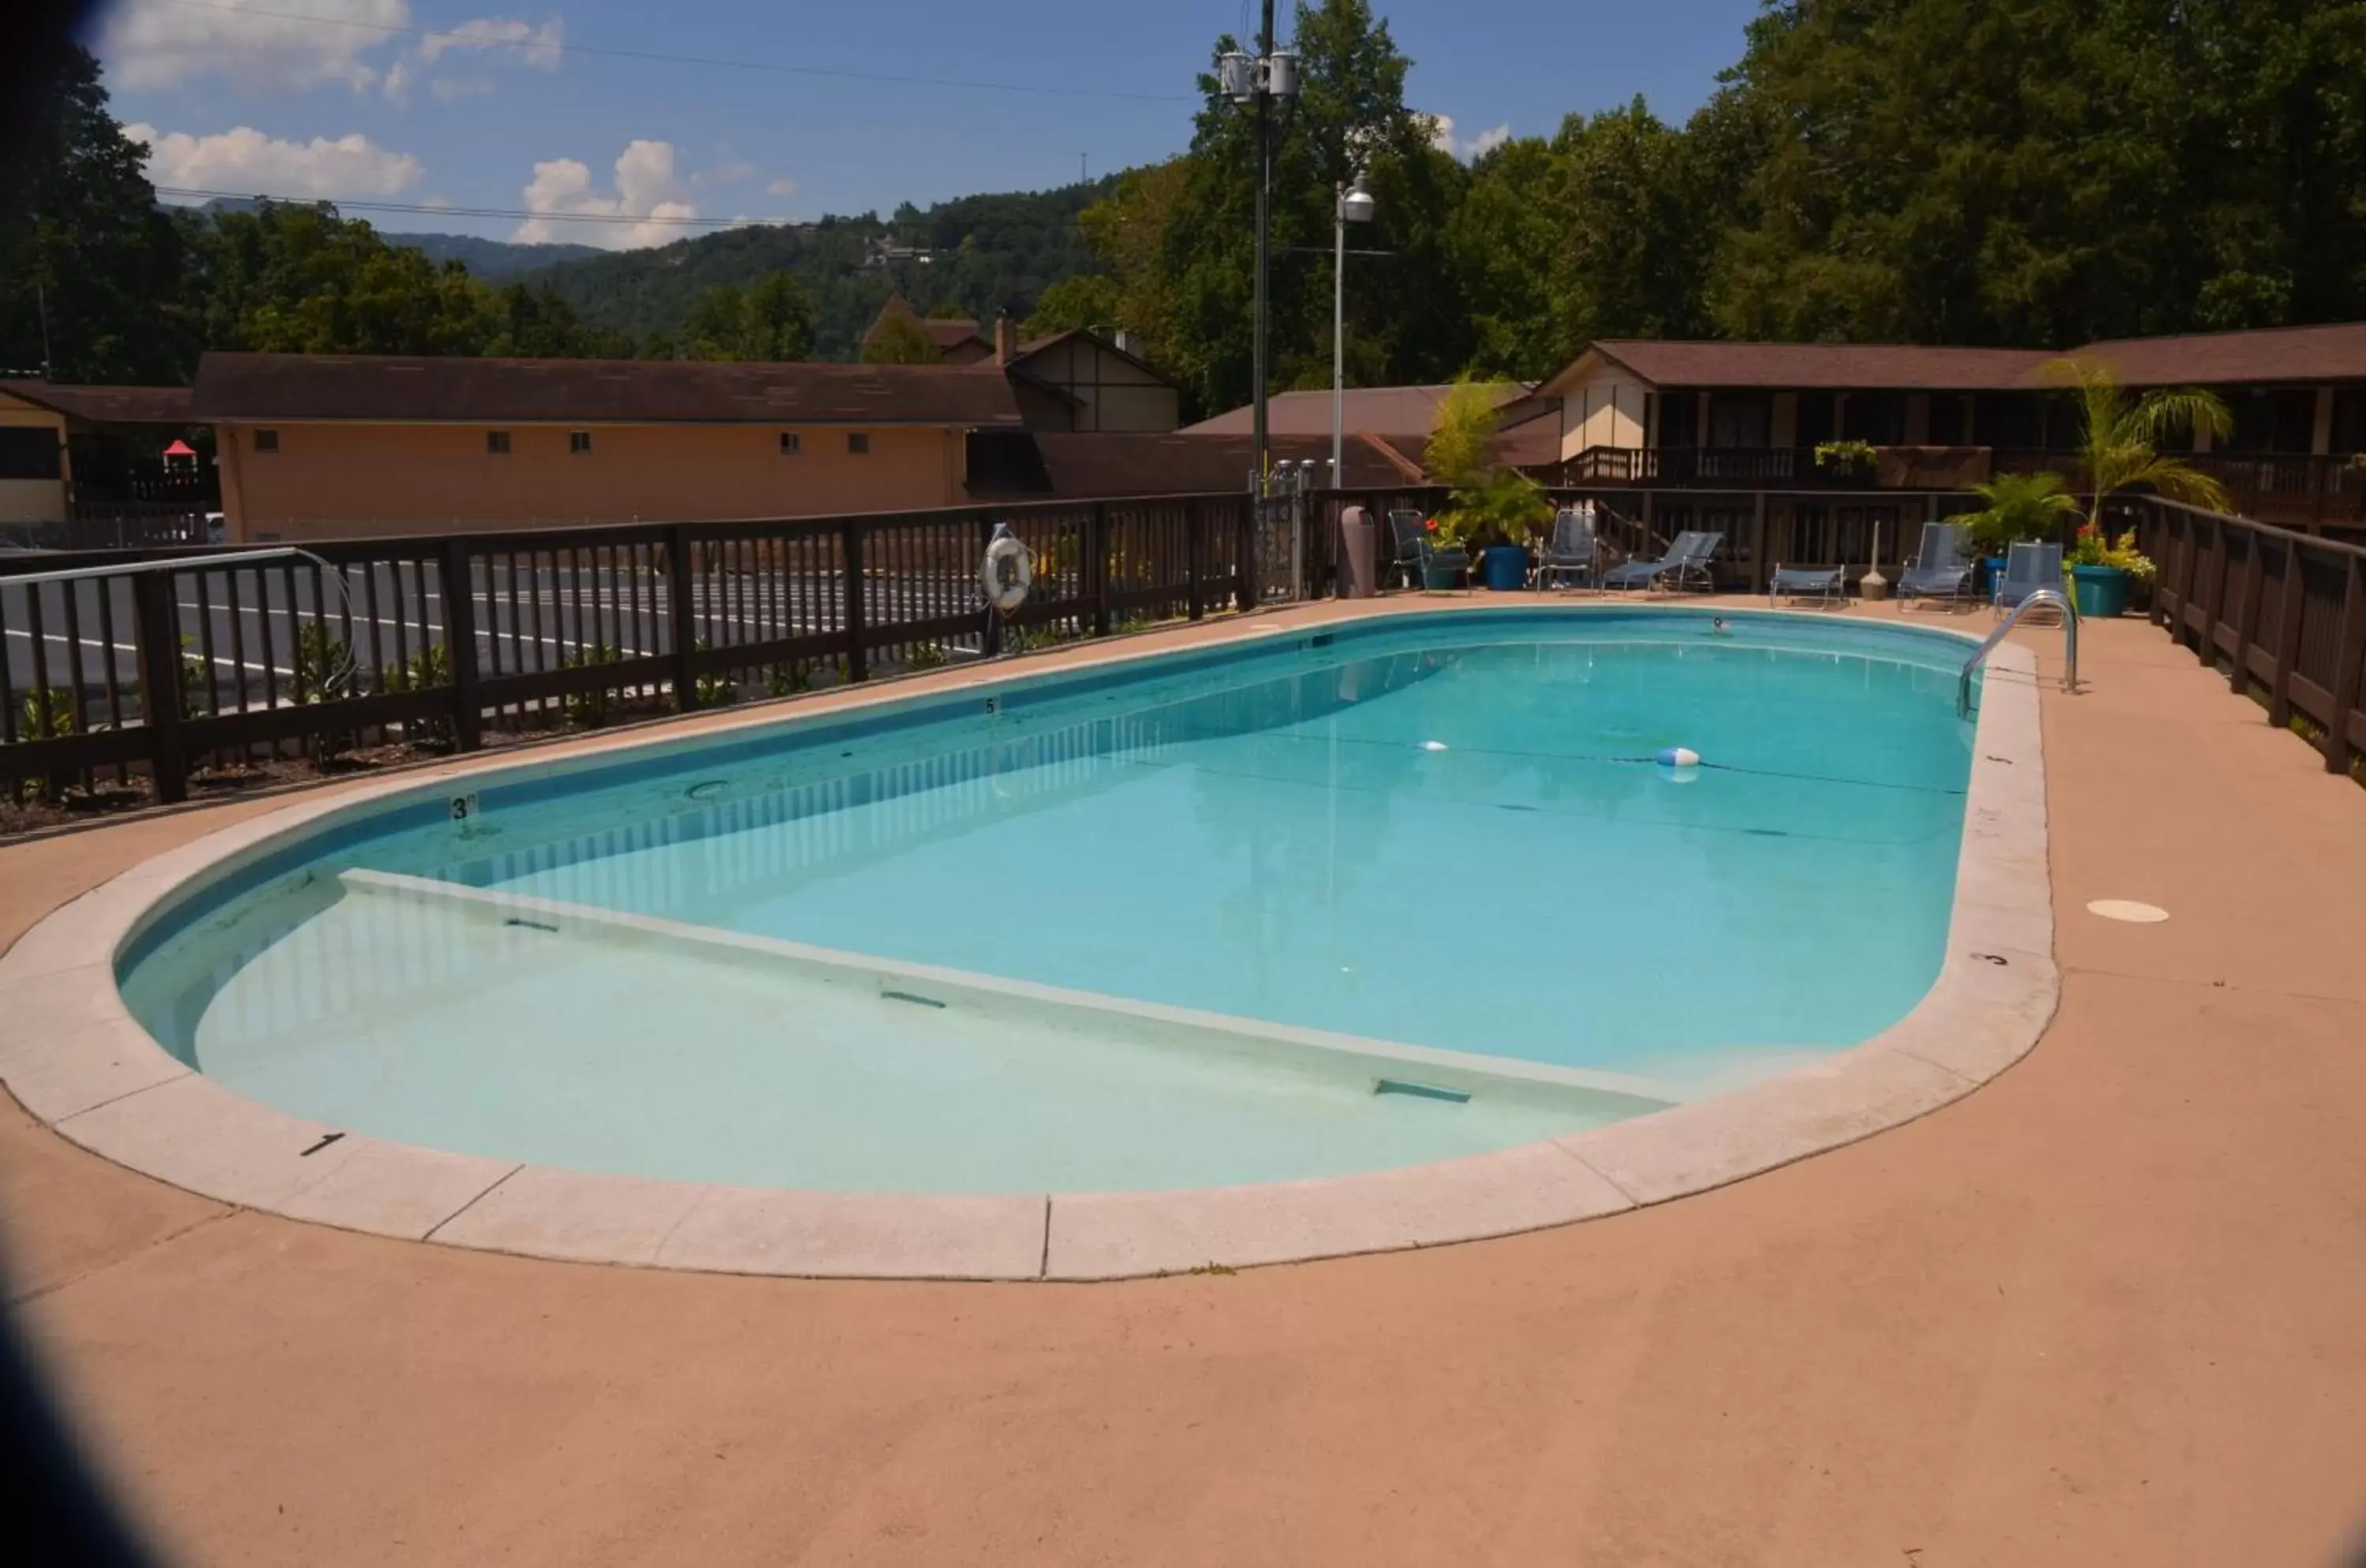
top-left (0, 47), bottom-right (196, 381)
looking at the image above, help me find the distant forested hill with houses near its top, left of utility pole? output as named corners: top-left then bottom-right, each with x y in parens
top-left (535, 180), bottom-right (1112, 360)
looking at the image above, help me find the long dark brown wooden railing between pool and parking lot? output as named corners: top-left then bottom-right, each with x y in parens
top-left (0, 495), bottom-right (1259, 801)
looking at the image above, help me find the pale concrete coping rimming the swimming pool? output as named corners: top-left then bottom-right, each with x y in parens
top-left (0, 599), bottom-right (2061, 1279)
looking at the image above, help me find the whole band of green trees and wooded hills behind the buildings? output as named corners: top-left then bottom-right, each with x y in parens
top-left (0, 0), bottom-right (2366, 399)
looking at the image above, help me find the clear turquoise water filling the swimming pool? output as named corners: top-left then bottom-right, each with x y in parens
top-left (125, 608), bottom-right (1971, 1189)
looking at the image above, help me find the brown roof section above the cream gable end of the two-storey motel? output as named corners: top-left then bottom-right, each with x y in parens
top-left (1547, 338), bottom-right (2054, 393)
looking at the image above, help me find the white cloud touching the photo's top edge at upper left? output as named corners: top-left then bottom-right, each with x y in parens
top-left (99, 0), bottom-right (412, 92)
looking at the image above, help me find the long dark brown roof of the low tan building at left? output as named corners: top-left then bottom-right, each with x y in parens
top-left (194, 355), bottom-right (1020, 428)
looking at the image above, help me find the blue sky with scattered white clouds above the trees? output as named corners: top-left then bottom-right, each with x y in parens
top-left (92, 0), bottom-right (1758, 246)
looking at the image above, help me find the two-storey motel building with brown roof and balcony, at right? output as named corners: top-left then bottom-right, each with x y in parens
top-left (1507, 324), bottom-right (2366, 582)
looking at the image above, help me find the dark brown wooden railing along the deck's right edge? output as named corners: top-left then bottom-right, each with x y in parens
top-left (2113, 499), bottom-right (2366, 774)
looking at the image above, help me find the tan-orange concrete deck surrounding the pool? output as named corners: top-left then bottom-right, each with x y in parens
top-left (0, 595), bottom-right (2366, 1566)
